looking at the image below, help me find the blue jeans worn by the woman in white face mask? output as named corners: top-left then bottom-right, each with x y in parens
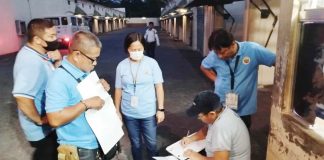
top-left (123, 115), bottom-right (157, 160)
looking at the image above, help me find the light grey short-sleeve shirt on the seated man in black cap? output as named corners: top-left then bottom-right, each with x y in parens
top-left (206, 108), bottom-right (251, 160)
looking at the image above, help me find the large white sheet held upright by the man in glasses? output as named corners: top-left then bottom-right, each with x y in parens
top-left (77, 71), bottom-right (124, 154)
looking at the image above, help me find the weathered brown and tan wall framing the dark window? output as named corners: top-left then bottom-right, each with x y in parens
top-left (267, 0), bottom-right (324, 160)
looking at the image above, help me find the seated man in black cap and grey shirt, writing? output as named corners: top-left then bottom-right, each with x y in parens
top-left (181, 91), bottom-right (251, 160)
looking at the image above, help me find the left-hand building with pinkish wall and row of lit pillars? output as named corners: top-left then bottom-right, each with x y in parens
top-left (0, 0), bottom-right (126, 55)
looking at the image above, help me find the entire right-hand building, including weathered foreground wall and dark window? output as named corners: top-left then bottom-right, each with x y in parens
top-left (161, 0), bottom-right (324, 160)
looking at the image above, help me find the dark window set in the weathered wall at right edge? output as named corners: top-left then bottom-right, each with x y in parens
top-left (293, 22), bottom-right (324, 124)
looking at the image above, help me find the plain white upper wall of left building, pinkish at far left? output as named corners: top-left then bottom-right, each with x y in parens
top-left (0, 0), bottom-right (124, 55)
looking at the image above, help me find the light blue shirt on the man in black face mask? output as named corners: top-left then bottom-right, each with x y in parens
top-left (12, 46), bottom-right (54, 141)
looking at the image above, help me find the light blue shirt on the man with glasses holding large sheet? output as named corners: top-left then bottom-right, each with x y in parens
top-left (46, 58), bottom-right (98, 149)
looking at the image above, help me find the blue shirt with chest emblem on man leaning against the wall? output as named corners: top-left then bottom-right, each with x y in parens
top-left (201, 42), bottom-right (276, 116)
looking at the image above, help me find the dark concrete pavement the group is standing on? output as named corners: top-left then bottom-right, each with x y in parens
top-left (0, 28), bottom-right (271, 160)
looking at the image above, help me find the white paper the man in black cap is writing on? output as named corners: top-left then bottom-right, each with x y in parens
top-left (166, 134), bottom-right (206, 160)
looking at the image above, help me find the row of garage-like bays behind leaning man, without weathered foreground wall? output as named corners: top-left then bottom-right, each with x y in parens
top-left (161, 0), bottom-right (280, 85)
